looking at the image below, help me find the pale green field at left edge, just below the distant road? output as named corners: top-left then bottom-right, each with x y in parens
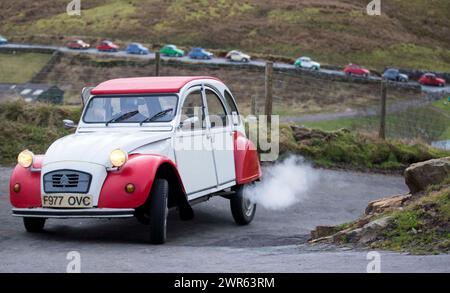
top-left (0, 53), bottom-right (51, 83)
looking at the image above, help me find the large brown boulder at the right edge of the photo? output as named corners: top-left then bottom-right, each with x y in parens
top-left (404, 157), bottom-right (450, 193)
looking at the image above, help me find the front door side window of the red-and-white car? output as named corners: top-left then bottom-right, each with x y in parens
top-left (181, 91), bottom-right (206, 130)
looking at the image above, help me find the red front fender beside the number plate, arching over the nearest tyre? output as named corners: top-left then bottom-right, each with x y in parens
top-left (98, 154), bottom-right (184, 208)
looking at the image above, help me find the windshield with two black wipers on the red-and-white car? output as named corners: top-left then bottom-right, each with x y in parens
top-left (83, 95), bottom-right (178, 124)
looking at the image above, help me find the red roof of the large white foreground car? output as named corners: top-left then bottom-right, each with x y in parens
top-left (91, 76), bottom-right (220, 95)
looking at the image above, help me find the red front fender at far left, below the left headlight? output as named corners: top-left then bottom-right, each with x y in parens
top-left (9, 156), bottom-right (43, 208)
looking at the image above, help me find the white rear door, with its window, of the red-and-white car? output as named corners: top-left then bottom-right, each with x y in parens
top-left (205, 87), bottom-right (236, 185)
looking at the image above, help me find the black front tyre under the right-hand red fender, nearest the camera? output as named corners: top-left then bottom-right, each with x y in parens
top-left (149, 178), bottom-right (169, 244)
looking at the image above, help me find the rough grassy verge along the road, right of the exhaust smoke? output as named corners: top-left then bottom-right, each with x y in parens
top-left (280, 125), bottom-right (450, 171)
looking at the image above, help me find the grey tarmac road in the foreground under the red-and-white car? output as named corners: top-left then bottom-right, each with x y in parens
top-left (0, 167), bottom-right (450, 272)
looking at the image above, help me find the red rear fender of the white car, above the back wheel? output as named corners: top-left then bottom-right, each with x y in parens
top-left (233, 131), bottom-right (261, 184)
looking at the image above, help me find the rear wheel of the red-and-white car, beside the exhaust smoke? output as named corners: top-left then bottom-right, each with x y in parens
top-left (230, 185), bottom-right (256, 225)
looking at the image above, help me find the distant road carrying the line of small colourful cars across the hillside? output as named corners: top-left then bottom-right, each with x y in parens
top-left (0, 43), bottom-right (450, 93)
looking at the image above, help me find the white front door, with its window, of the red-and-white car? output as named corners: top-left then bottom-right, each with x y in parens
top-left (174, 87), bottom-right (217, 199)
